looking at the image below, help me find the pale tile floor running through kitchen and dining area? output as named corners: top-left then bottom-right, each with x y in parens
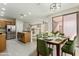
top-left (0, 39), bottom-right (79, 56)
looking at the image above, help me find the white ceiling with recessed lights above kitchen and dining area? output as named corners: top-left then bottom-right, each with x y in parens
top-left (0, 3), bottom-right (79, 22)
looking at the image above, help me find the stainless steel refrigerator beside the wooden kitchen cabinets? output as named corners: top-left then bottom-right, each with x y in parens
top-left (6, 25), bottom-right (16, 39)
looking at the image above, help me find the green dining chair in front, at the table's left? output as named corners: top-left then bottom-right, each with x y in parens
top-left (37, 39), bottom-right (53, 56)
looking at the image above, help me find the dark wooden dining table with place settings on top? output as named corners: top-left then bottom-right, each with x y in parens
top-left (45, 37), bottom-right (68, 56)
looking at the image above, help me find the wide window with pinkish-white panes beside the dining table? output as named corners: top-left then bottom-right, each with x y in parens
top-left (53, 13), bottom-right (77, 38)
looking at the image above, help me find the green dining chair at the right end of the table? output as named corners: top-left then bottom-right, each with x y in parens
top-left (61, 36), bottom-right (76, 56)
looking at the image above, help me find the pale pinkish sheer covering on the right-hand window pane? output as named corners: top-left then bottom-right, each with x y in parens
top-left (63, 13), bottom-right (77, 38)
